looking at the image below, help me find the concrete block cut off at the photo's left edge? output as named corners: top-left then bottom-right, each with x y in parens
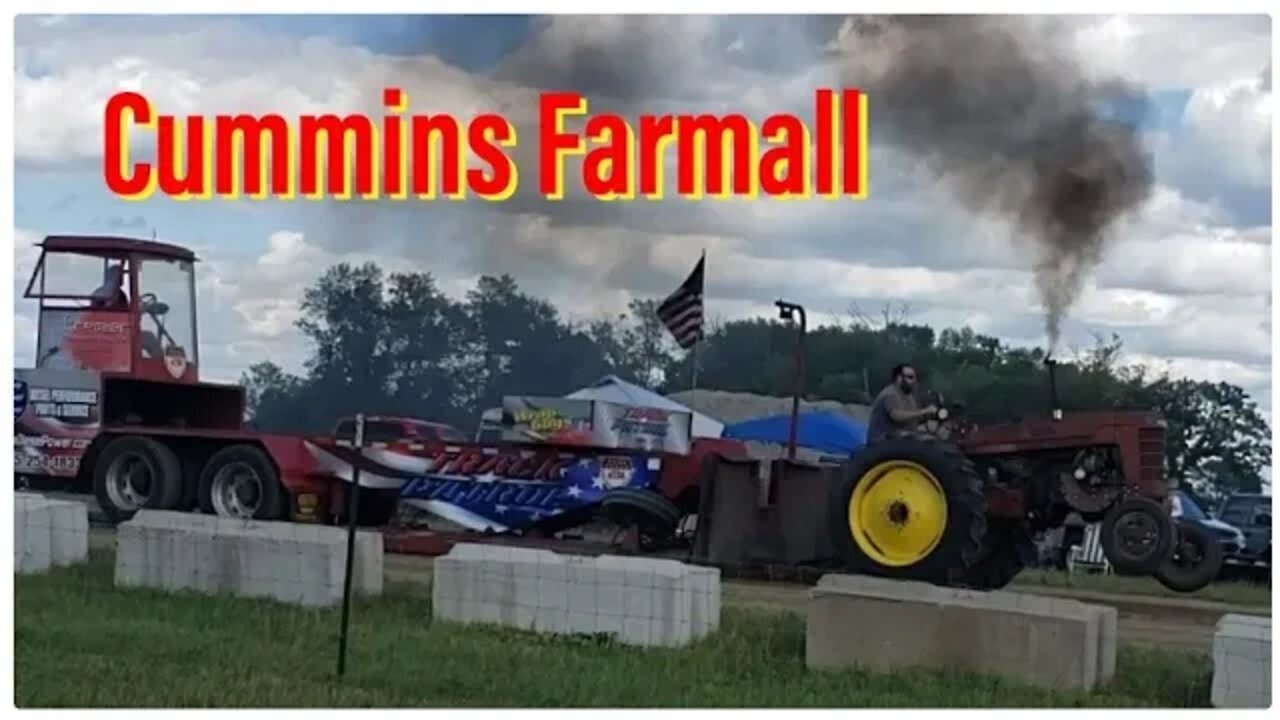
top-left (13, 492), bottom-right (88, 573)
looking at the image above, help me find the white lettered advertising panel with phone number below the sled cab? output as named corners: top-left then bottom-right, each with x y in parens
top-left (13, 369), bottom-right (99, 478)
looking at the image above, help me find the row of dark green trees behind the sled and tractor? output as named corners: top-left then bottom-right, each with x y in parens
top-left (242, 263), bottom-right (1271, 500)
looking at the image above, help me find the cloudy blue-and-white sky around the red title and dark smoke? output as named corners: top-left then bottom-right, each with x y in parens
top-left (15, 15), bottom-right (1271, 415)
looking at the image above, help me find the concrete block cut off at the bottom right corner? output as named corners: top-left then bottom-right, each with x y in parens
top-left (1211, 614), bottom-right (1271, 707)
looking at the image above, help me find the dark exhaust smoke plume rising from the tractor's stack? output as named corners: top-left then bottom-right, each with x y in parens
top-left (842, 15), bottom-right (1153, 351)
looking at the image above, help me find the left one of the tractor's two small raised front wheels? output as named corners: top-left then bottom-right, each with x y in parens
top-left (1101, 497), bottom-right (1176, 577)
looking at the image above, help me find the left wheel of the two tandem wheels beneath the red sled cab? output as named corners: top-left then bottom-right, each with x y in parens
top-left (93, 436), bottom-right (182, 523)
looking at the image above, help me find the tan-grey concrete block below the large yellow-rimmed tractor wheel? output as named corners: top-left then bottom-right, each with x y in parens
top-left (805, 575), bottom-right (1117, 689)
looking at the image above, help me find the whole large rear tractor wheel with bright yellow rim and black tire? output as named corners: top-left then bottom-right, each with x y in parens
top-left (831, 433), bottom-right (987, 585)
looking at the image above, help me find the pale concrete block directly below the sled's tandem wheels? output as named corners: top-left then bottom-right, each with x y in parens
top-left (115, 510), bottom-right (383, 607)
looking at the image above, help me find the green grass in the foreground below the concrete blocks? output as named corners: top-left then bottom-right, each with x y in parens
top-left (14, 551), bottom-right (1211, 707)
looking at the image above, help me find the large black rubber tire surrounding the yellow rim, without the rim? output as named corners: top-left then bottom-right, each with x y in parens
top-left (828, 433), bottom-right (987, 585)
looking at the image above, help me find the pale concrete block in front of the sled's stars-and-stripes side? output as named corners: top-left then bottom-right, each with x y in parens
top-left (431, 543), bottom-right (721, 647)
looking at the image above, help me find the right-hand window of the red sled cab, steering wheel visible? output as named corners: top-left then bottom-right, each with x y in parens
top-left (138, 258), bottom-right (200, 364)
